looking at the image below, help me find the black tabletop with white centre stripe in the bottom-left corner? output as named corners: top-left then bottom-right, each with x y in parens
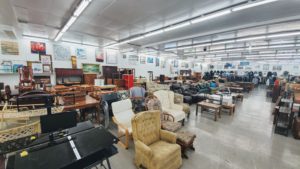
top-left (7, 126), bottom-right (118, 169)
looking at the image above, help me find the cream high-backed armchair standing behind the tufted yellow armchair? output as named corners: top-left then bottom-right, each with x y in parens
top-left (153, 90), bottom-right (186, 124)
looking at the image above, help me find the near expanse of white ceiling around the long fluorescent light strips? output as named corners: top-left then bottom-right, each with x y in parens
top-left (0, 0), bottom-right (300, 54)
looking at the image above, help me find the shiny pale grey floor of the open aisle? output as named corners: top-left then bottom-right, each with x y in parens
top-left (111, 87), bottom-right (300, 169)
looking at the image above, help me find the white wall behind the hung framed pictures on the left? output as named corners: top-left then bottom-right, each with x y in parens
top-left (0, 38), bottom-right (185, 87)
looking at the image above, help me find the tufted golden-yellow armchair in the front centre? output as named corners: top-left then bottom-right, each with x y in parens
top-left (131, 111), bottom-right (182, 169)
